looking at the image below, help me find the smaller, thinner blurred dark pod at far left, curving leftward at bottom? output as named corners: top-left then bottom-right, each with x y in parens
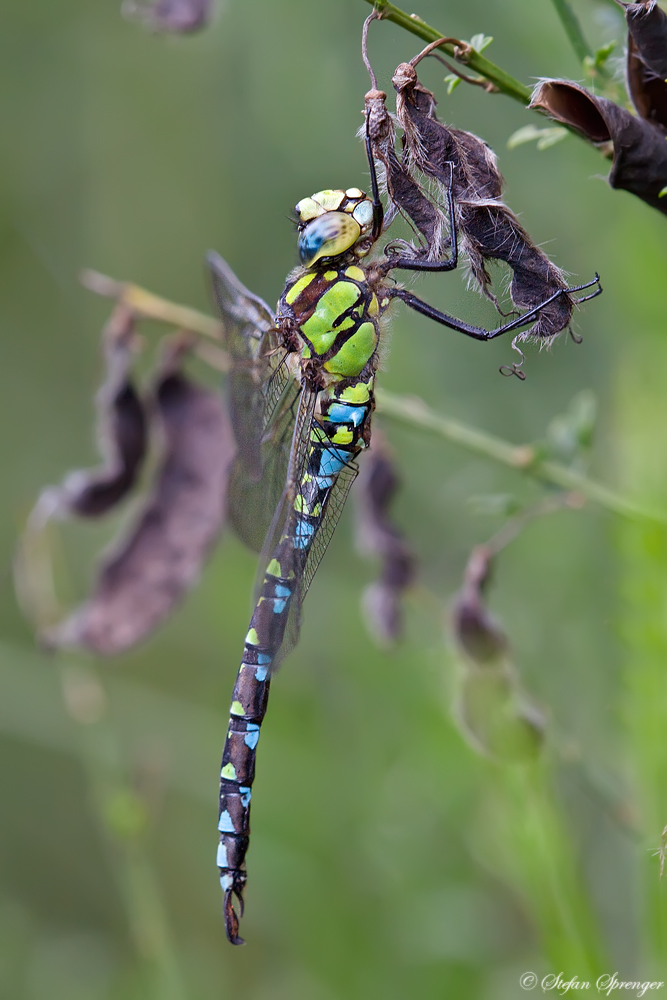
top-left (33, 305), bottom-right (148, 520)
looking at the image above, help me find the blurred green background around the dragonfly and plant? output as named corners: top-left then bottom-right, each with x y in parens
top-left (0, 0), bottom-right (667, 1000)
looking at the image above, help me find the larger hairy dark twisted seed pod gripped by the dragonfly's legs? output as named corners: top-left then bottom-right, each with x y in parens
top-left (392, 63), bottom-right (573, 341)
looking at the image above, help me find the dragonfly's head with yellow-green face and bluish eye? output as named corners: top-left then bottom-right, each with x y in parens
top-left (296, 188), bottom-right (373, 267)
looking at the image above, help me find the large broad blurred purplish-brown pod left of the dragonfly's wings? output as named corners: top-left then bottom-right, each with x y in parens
top-left (45, 351), bottom-right (234, 656)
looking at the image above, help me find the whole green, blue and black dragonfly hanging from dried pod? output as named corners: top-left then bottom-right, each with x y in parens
top-left (208, 109), bottom-right (601, 945)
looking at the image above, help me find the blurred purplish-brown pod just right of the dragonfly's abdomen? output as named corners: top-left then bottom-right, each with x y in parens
top-left (356, 432), bottom-right (415, 645)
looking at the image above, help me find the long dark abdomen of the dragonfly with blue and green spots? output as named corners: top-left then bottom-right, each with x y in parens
top-left (217, 376), bottom-right (373, 944)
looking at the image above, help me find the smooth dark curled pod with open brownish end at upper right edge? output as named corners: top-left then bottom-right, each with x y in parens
top-left (530, 80), bottom-right (667, 215)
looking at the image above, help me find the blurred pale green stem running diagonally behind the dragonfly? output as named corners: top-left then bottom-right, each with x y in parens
top-left (82, 271), bottom-right (667, 525)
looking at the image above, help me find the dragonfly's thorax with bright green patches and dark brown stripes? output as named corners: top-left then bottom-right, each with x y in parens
top-left (278, 265), bottom-right (381, 378)
